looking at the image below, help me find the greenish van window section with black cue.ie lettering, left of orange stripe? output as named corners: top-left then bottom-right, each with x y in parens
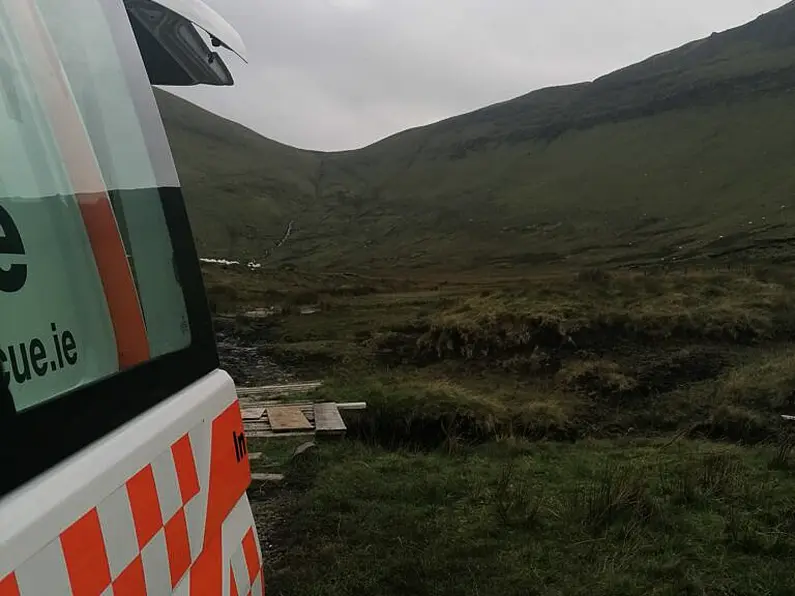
top-left (0, 5), bottom-right (118, 410)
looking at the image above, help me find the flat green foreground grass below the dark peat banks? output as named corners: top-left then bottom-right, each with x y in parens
top-left (266, 441), bottom-right (795, 596)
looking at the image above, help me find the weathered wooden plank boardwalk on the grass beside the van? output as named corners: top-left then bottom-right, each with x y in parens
top-left (237, 381), bottom-right (367, 438)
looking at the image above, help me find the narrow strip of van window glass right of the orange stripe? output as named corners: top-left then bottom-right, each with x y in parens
top-left (37, 0), bottom-right (190, 356)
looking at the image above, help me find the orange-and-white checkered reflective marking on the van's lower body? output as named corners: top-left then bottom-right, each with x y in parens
top-left (0, 402), bottom-right (262, 596)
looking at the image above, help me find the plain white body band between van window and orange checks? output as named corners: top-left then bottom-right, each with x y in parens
top-left (0, 370), bottom-right (236, 578)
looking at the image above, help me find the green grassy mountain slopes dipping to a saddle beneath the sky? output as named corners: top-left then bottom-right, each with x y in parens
top-left (159, 3), bottom-right (795, 268)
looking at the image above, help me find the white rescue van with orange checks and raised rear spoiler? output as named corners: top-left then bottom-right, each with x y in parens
top-left (0, 0), bottom-right (264, 596)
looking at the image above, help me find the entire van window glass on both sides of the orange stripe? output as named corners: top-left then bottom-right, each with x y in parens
top-left (0, 0), bottom-right (191, 411)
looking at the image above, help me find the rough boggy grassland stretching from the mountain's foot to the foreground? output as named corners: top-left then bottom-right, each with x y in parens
top-left (206, 268), bottom-right (795, 595)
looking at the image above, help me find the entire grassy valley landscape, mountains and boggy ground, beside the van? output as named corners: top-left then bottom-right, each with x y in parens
top-left (169, 3), bottom-right (795, 596)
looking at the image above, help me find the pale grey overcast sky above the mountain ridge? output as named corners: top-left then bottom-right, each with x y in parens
top-left (166, 0), bottom-right (784, 150)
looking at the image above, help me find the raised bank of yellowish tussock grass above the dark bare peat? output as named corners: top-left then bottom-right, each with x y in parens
top-left (417, 273), bottom-right (795, 359)
